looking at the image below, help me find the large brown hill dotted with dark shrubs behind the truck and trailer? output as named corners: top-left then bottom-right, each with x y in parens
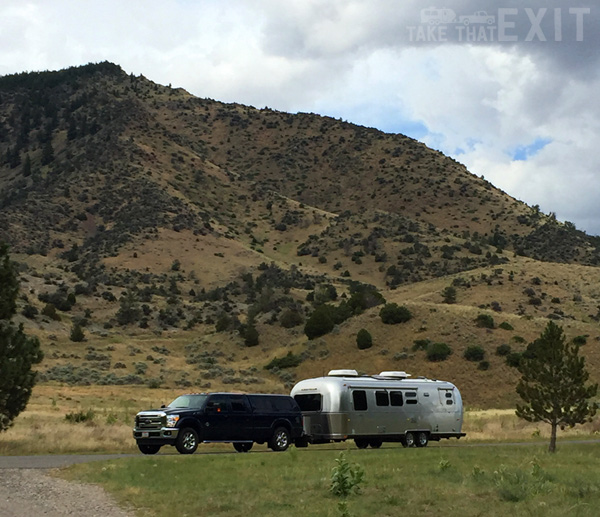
top-left (0, 63), bottom-right (600, 406)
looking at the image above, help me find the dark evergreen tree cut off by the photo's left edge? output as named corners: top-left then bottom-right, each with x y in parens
top-left (0, 243), bottom-right (43, 431)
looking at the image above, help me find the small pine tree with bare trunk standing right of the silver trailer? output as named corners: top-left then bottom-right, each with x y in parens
top-left (517, 322), bottom-right (598, 452)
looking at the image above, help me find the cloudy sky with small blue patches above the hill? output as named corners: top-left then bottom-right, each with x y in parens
top-left (0, 0), bottom-right (600, 235)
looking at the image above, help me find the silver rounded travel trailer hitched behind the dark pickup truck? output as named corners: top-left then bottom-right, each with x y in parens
top-left (291, 370), bottom-right (465, 449)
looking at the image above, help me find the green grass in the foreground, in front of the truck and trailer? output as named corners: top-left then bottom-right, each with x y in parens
top-left (62, 442), bottom-right (600, 517)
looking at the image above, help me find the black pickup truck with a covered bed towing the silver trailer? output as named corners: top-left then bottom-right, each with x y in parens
top-left (133, 393), bottom-right (305, 454)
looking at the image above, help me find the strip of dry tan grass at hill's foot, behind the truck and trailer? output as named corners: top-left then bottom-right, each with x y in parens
top-left (0, 385), bottom-right (600, 455)
